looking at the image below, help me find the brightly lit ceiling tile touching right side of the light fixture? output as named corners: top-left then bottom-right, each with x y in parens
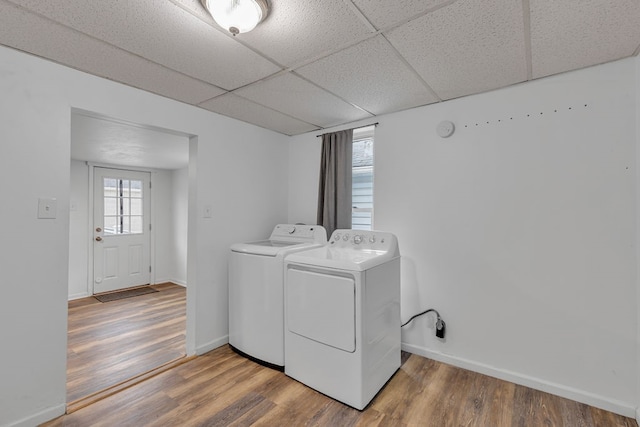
top-left (238, 0), bottom-right (370, 67)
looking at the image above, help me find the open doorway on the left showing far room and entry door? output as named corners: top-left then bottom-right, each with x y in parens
top-left (67, 109), bottom-right (197, 412)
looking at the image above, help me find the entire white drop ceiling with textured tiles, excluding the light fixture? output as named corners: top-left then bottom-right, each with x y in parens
top-left (0, 0), bottom-right (640, 135)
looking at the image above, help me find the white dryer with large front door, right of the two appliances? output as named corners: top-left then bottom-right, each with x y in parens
top-left (285, 230), bottom-right (401, 409)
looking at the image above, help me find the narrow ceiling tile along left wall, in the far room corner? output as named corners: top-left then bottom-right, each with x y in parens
top-left (200, 93), bottom-right (318, 135)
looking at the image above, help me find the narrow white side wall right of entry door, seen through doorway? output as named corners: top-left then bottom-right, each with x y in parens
top-left (169, 168), bottom-right (189, 286)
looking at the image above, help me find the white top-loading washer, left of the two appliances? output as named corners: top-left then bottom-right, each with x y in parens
top-left (229, 224), bottom-right (327, 370)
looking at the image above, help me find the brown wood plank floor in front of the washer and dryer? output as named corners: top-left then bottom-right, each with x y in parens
top-left (44, 346), bottom-right (637, 427)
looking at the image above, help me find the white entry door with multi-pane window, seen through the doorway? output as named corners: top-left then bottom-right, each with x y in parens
top-left (93, 167), bottom-right (151, 293)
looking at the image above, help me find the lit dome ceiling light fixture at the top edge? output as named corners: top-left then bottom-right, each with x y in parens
top-left (200, 0), bottom-right (269, 36)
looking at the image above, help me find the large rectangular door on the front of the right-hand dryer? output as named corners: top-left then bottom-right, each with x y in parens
top-left (286, 265), bottom-right (356, 353)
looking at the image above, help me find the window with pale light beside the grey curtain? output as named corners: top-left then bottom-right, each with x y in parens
top-left (351, 126), bottom-right (375, 230)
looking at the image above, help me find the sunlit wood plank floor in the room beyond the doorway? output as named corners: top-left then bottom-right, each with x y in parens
top-left (67, 283), bottom-right (186, 403)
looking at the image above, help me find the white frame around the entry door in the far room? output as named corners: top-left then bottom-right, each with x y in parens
top-left (87, 162), bottom-right (157, 295)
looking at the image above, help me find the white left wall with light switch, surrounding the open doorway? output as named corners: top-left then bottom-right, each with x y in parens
top-left (0, 47), bottom-right (288, 425)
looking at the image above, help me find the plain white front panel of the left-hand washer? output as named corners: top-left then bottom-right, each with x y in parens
top-left (229, 252), bottom-right (284, 366)
